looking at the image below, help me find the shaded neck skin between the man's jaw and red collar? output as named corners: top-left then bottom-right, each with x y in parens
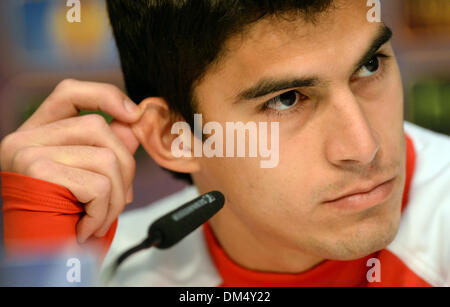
top-left (209, 206), bottom-right (324, 274)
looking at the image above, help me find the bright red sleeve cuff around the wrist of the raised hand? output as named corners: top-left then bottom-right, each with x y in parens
top-left (0, 172), bottom-right (117, 262)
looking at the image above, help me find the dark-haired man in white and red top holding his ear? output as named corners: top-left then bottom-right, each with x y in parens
top-left (1, 0), bottom-right (450, 286)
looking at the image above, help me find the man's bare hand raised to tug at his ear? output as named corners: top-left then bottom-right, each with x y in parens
top-left (0, 79), bottom-right (142, 242)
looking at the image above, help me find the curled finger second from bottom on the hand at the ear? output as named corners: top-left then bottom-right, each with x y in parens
top-left (12, 146), bottom-right (128, 236)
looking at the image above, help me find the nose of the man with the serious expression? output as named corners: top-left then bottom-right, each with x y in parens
top-left (326, 89), bottom-right (380, 167)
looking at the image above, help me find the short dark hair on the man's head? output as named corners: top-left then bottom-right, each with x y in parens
top-left (107, 0), bottom-right (332, 183)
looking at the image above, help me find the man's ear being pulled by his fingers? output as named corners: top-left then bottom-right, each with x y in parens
top-left (131, 97), bottom-right (200, 173)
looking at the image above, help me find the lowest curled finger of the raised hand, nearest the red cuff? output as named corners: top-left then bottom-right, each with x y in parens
top-left (26, 159), bottom-right (112, 243)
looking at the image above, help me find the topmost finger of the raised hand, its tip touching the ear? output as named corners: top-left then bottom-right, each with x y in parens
top-left (18, 79), bottom-right (142, 131)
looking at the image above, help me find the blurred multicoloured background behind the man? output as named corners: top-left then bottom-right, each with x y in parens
top-left (0, 0), bottom-right (450, 250)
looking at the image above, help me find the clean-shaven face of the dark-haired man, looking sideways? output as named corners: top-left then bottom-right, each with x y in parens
top-left (193, 1), bottom-right (405, 260)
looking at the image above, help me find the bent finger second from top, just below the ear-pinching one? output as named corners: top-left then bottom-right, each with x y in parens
top-left (5, 114), bottom-right (136, 194)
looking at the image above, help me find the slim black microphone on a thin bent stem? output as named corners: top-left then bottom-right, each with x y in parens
top-left (109, 191), bottom-right (225, 279)
